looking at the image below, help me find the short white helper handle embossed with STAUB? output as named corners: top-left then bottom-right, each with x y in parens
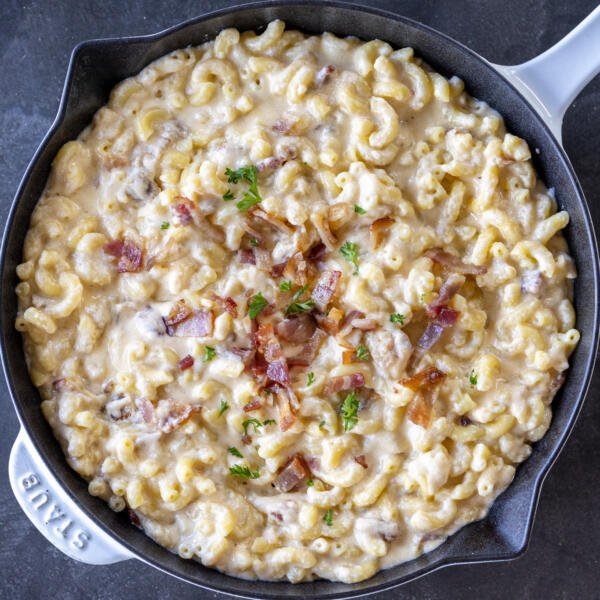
top-left (8, 429), bottom-right (133, 565)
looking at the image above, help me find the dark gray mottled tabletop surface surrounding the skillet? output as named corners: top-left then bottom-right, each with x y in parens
top-left (0, 0), bottom-right (600, 600)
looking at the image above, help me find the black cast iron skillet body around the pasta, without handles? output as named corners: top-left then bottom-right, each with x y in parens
top-left (0, 2), bottom-right (599, 598)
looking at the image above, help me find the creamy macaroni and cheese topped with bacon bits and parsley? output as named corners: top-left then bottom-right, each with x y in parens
top-left (16, 21), bottom-right (579, 582)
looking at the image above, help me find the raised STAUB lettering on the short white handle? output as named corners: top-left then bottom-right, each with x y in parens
top-left (21, 473), bottom-right (91, 550)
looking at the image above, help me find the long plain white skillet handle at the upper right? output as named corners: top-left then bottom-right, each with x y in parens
top-left (492, 6), bottom-right (600, 143)
